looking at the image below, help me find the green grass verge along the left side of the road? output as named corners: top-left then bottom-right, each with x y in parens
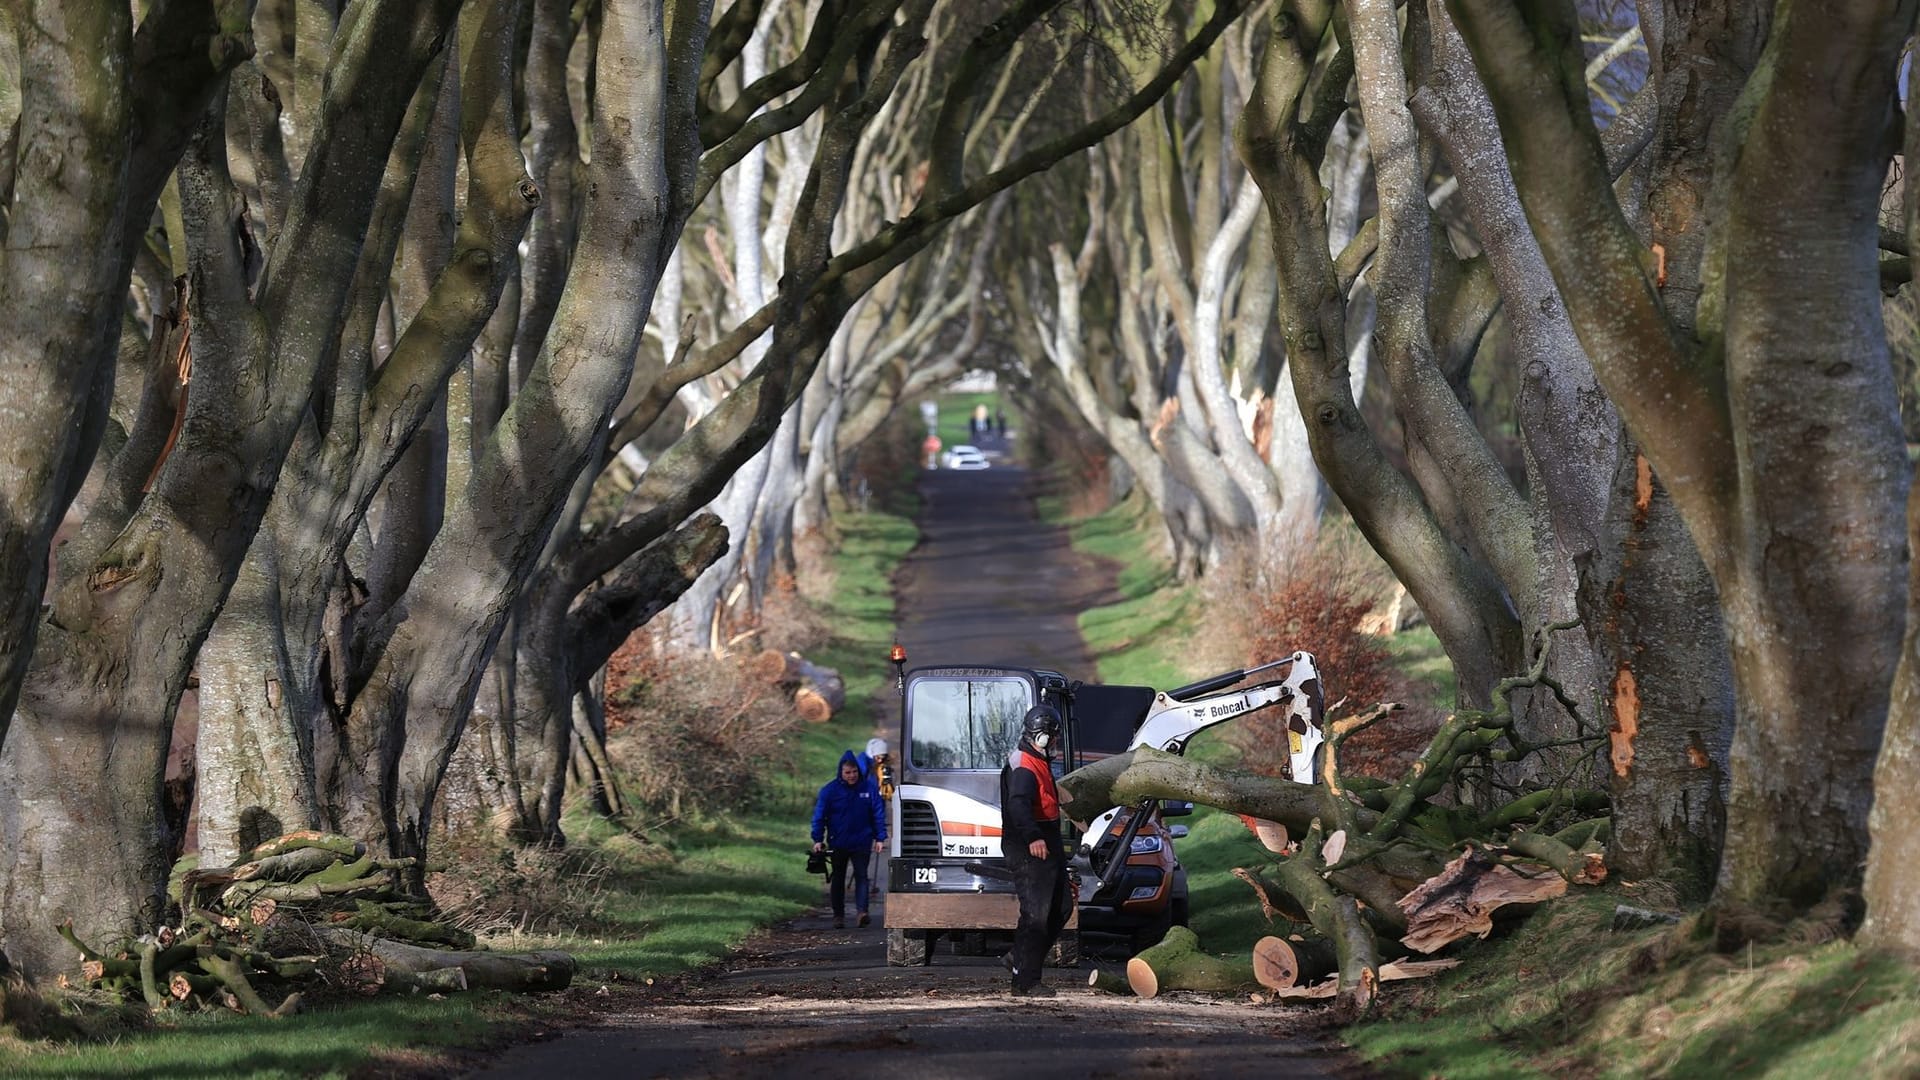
top-left (0, 513), bottom-right (918, 1078)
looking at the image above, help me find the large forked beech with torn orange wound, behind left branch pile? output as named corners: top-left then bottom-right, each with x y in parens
top-left (0, 2), bottom-right (455, 972)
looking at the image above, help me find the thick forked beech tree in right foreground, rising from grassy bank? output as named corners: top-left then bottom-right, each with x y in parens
top-left (1448, 0), bottom-right (1914, 910)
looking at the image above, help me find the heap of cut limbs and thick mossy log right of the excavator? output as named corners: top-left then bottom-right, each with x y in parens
top-left (1060, 626), bottom-right (1609, 1020)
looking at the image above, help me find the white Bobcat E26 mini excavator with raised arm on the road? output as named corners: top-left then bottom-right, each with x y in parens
top-left (885, 646), bottom-right (1325, 967)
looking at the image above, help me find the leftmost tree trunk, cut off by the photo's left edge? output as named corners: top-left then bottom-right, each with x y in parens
top-left (0, 2), bottom-right (133, 744)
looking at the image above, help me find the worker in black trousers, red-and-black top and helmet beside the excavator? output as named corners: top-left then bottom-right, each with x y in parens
top-left (1000, 705), bottom-right (1073, 997)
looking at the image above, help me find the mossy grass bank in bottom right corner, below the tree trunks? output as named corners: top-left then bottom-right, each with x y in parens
top-left (1346, 886), bottom-right (1920, 1080)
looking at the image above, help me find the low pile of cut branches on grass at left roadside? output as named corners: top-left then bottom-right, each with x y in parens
top-left (60, 832), bottom-right (574, 1017)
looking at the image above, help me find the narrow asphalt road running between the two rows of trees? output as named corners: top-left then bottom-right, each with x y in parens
top-left (460, 467), bottom-right (1369, 1080)
